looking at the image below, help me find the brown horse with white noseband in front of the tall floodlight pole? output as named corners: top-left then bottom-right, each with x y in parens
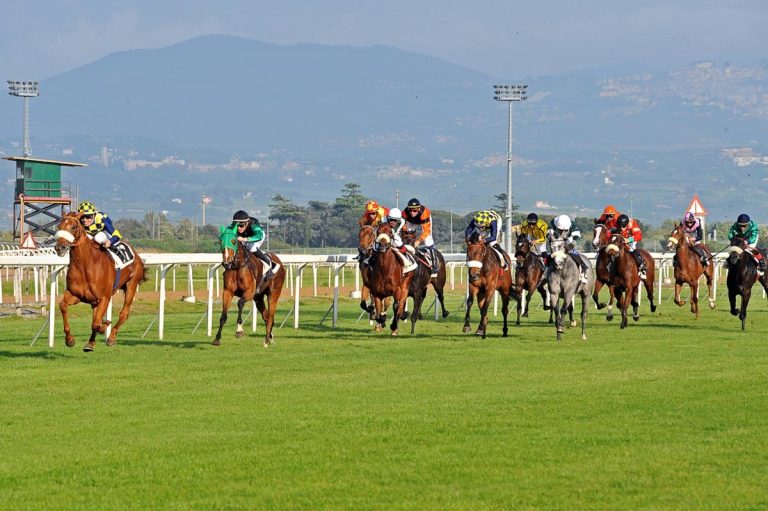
top-left (463, 232), bottom-right (519, 339)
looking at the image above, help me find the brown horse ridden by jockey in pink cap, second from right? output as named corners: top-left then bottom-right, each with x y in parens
top-left (667, 224), bottom-right (715, 319)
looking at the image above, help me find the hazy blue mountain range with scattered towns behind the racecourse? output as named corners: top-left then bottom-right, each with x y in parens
top-left (0, 35), bottom-right (768, 228)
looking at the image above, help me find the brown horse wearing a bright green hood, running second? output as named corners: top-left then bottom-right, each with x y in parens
top-left (211, 227), bottom-right (285, 348)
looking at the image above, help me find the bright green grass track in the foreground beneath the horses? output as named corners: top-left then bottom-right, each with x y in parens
top-left (0, 288), bottom-right (768, 510)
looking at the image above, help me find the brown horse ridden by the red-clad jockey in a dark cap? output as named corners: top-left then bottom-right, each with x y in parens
top-left (605, 234), bottom-right (656, 328)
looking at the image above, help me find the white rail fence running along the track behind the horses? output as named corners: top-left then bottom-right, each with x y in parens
top-left (0, 247), bottom-right (748, 347)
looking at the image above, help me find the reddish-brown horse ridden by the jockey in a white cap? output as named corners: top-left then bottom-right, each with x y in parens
top-left (368, 223), bottom-right (413, 336)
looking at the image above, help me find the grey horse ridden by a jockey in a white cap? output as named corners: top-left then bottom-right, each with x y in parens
top-left (545, 250), bottom-right (595, 341)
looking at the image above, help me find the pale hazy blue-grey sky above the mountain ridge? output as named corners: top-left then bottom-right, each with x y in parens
top-left (0, 0), bottom-right (768, 79)
